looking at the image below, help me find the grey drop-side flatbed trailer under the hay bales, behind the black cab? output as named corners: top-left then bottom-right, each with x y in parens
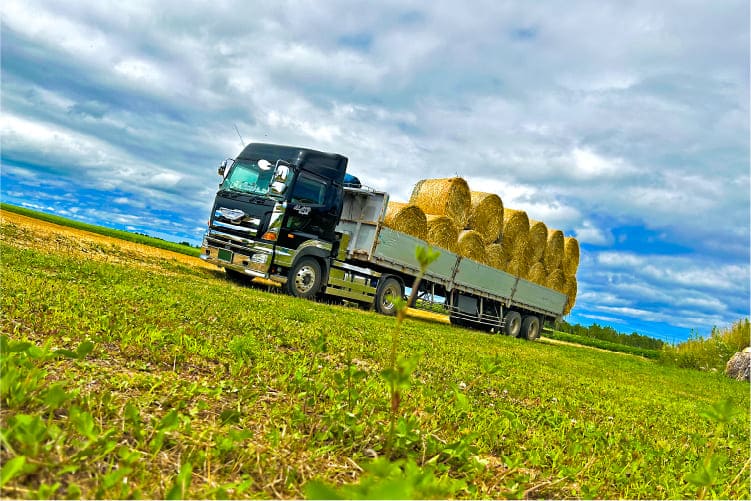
top-left (326, 188), bottom-right (566, 337)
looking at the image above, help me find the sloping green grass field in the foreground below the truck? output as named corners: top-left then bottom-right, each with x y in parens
top-left (0, 207), bottom-right (749, 499)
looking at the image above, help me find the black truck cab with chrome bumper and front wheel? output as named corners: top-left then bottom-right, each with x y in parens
top-left (201, 143), bottom-right (347, 297)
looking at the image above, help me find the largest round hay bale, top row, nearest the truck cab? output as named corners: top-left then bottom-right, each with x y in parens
top-left (409, 177), bottom-right (472, 228)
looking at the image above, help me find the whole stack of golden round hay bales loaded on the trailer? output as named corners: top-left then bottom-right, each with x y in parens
top-left (396, 177), bottom-right (579, 314)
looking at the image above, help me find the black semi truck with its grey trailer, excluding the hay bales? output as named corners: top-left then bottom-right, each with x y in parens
top-left (201, 143), bottom-right (566, 340)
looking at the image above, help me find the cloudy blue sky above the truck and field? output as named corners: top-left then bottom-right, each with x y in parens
top-left (0, 0), bottom-right (751, 342)
